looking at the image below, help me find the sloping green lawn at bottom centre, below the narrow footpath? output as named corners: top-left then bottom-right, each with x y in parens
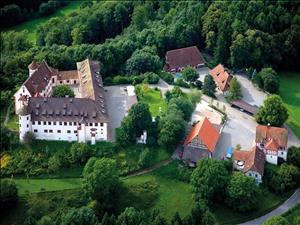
top-left (121, 164), bottom-right (194, 220)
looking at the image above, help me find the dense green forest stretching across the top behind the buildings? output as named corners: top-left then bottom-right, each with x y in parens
top-left (0, 1), bottom-right (300, 108)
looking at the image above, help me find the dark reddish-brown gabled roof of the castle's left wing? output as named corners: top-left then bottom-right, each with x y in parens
top-left (24, 60), bottom-right (57, 96)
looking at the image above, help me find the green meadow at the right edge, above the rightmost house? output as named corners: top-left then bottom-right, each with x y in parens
top-left (279, 72), bottom-right (300, 139)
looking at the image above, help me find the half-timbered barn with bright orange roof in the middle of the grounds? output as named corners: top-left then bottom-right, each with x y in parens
top-left (182, 117), bottom-right (221, 165)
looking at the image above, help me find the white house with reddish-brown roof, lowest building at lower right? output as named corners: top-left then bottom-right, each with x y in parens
top-left (233, 146), bottom-right (265, 183)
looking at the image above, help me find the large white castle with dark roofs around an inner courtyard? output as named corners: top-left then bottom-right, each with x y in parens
top-left (14, 59), bottom-right (108, 144)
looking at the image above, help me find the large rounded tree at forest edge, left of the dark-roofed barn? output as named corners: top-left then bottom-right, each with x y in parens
top-left (126, 47), bottom-right (161, 75)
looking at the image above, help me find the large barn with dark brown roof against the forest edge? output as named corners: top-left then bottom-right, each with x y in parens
top-left (164, 46), bottom-right (205, 72)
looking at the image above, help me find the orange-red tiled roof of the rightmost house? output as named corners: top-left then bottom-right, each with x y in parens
top-left (255, 125), bottom-right (288, 150)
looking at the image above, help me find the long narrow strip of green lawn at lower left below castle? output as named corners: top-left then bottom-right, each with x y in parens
top-left (6, 178), bottom-right (81, 195)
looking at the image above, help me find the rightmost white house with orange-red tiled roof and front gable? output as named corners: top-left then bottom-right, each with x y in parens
top-left (255, 125), bottom-right (288, 165)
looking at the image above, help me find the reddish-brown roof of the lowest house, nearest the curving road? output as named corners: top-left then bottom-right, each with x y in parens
top-left (233, 146), bottom-right (266, 176)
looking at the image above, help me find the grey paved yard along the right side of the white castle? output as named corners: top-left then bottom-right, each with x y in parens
top-left (105, 85), bottom-right (137, 141)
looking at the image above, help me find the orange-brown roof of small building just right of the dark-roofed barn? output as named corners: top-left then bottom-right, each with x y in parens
top-left (209, 64), bottom-right (232, 91)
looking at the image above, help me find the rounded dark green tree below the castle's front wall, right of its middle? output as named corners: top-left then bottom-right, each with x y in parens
top-left (70, 143), bottom-right (93, 165)
